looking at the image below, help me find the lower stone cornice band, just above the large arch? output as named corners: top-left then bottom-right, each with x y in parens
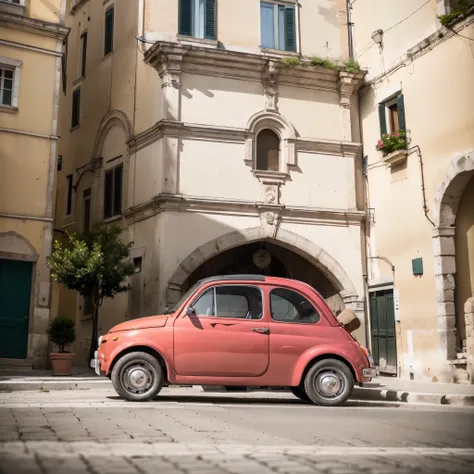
top-left (124, 194), bottom-right (365, 226)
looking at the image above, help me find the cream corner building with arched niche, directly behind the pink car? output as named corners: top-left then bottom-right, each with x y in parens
top-left (56, 0), bottom-right (366, 363)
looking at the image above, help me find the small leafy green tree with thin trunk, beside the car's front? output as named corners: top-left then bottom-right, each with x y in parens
top-left (48, 222), bottom-right (133, 361)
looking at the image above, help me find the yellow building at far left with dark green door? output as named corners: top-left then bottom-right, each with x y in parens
top-left (0, 0), bottom-right (68, 367)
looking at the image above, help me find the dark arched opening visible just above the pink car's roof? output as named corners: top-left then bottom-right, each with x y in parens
top-left (183, 240), bottom-right (344, 313)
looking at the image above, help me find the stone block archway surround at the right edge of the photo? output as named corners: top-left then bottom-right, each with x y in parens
top-left (433, 152), bottom-right (474, 361)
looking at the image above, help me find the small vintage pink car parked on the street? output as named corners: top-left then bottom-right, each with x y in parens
top-left (95, 275), bottom-right (375, 405)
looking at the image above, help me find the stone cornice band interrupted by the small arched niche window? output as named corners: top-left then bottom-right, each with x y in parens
top-left (128, 120), bottom-right (361, 158)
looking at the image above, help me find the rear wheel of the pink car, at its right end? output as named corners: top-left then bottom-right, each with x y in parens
top-left (304, 359), bottom-right (354, 406)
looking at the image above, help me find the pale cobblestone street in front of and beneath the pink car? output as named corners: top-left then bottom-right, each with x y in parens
top-left (0, 388), bottom-right (474, 474)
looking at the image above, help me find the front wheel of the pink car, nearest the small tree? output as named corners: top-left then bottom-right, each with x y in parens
top-left (112, 352), bottom-right (164, 402)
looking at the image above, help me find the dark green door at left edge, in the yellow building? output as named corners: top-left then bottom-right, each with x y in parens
top-left (0, 259), bottom-right (32, 359)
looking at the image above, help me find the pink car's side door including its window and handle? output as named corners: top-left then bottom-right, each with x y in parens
top-left (174, 284), bottom-right (269, 377)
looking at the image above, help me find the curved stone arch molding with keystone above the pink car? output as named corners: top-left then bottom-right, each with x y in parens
top-left (166, 227), bottom-right (357, 306)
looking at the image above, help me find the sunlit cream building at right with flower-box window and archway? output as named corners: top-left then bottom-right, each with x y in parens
top-left (352, 0), bottom-right (474, 383)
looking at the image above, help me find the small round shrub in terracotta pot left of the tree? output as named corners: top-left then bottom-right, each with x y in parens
top-left (48, 316), bottom-right (76, 375)
